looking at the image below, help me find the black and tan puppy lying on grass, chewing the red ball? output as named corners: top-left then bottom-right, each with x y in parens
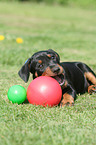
top-left (19, 50), bottom-right (96, 107)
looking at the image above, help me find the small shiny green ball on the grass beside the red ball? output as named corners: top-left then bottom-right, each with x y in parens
top-left (7, 85), bottom-right (27, 104)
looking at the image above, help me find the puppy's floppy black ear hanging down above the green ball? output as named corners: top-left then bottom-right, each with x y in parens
top-left (18, 58), bottom-right (31, 83)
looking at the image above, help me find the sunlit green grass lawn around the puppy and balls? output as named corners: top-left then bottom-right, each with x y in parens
top-left (0, 2), bottom-right (96, 145)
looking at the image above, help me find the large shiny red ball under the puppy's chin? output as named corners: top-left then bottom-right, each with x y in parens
top-left (27, 76), bottom-right (62, 107)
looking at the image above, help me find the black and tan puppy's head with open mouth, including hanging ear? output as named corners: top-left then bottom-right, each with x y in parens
top-left (18, 50), bottom-right (64, 86)
